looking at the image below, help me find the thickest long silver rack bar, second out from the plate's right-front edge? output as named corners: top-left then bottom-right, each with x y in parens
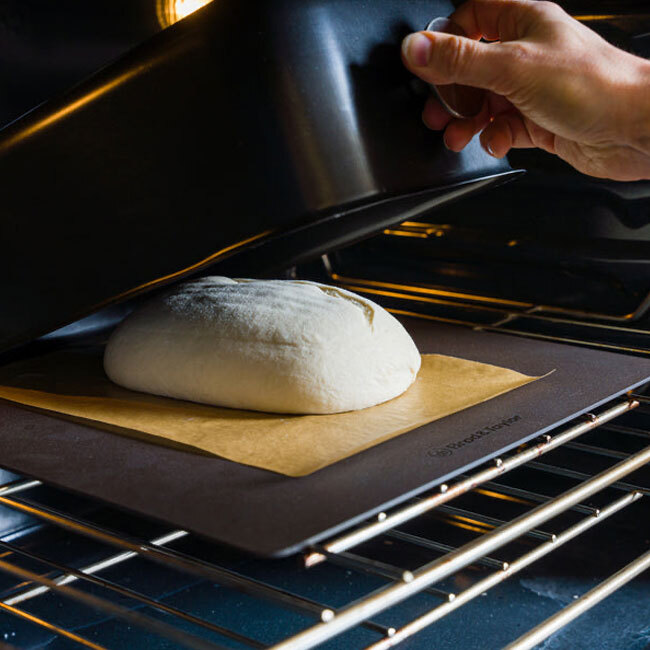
top-left (274, 438), bottom-right (650, 650)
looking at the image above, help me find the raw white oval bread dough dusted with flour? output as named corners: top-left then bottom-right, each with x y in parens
top-left (104, 277), bottom-right (420, 413)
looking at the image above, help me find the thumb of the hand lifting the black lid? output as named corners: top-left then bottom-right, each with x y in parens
top-left (402, 32), bottom-right (513, 95)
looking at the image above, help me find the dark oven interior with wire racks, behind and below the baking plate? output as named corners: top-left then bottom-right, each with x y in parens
top-left (0, 2), bottom-right (650, 650)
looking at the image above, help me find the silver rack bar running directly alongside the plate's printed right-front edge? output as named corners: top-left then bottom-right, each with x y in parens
top-left (304, 400), bottom-right (639, 567)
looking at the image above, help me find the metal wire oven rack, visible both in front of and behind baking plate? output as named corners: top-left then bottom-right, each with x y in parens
top-left (0, 275), bottom-right (650, 648)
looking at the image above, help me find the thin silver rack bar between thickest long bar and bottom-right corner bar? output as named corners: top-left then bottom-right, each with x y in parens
top-left (367, 492), bottom-right (642, 650)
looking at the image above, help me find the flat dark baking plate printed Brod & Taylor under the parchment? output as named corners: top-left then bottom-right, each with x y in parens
top-left (0, 319), bottom-right (650, 556)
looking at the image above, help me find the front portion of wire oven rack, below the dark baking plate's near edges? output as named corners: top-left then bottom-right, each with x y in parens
top-left (0, 395), bottom-right (650, 649)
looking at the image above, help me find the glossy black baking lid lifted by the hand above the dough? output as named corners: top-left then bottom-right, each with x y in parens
top-left (0, 0), bottom-right (511, 351)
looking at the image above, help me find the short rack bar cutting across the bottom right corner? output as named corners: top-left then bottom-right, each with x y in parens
top-left (505, 551), bottom-right (650, 650)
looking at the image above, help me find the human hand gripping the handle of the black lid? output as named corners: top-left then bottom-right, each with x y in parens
top-left (402, 0), bottom-right (650, 181)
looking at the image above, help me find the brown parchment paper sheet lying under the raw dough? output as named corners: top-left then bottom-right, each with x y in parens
top-left (0, 348), bottom-right (538, 476)
